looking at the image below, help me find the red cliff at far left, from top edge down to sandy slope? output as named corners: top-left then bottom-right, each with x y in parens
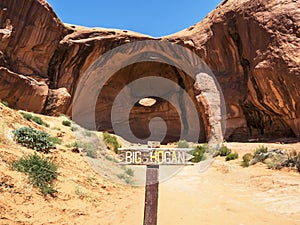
top-left (0, 0), bottom-right (68, 113)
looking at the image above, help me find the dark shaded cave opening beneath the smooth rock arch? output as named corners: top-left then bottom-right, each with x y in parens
top-left (95, 61), bottom-right (208, 144)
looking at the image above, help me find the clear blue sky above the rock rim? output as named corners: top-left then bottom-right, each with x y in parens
top-left (48, 0), bottom-right (222, 37)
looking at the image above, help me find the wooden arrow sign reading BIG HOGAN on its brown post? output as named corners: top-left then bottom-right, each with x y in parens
top-left (118, 144), bottom-right (193, 225)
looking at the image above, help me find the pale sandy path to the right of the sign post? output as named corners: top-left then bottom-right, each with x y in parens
top-left (158, 159), bottom-right (300, 225)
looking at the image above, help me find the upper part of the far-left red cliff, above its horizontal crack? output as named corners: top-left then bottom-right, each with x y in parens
top-left (0, 0), bottom-right (68, 77)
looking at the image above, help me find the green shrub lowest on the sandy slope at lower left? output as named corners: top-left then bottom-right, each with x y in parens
top-left (12, 153), bottom-right (58, 196)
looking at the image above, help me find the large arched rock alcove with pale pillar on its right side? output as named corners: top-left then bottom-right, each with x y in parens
top-left (72, 40), bottom-right (225, 142)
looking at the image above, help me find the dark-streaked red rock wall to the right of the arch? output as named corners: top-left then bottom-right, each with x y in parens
top-left (167, 0), bottom-right (300, 140)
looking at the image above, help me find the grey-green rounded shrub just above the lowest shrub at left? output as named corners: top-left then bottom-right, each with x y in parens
top-left (13, 127), bottom-right (54, 153)
